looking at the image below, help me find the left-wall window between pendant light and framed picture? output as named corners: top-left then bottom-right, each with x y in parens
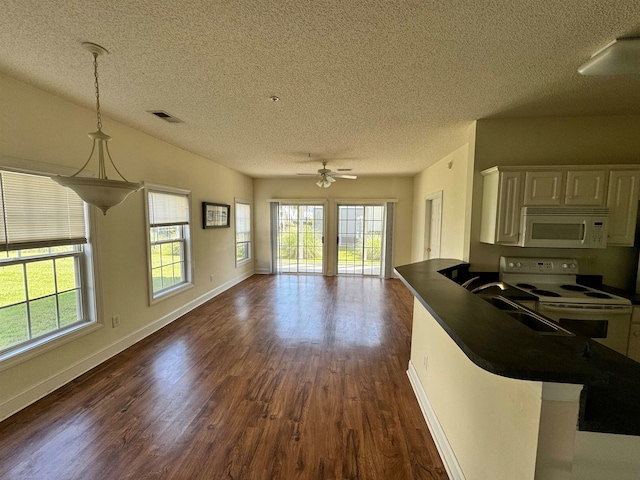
top-left (146, 186), bottom-right (193, 303)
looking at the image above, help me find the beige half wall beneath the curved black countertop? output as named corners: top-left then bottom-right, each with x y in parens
top-left (411, 300), bottom-right (544, 480)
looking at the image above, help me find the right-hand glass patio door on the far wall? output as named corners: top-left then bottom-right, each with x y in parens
top-left (338, 205), bottom-right (385, 276)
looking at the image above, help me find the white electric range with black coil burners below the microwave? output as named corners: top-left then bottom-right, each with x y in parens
top-left (500, 257), bottom-right (633, 355)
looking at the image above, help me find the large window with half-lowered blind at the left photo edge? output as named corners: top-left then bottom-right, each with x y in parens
top-left (0, 170), bottom-right (95, 359)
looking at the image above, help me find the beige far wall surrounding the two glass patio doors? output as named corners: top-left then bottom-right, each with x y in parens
top-left (254, 177), bottom-right (413, 274)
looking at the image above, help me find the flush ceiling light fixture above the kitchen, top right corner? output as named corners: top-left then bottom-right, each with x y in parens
top-left (578, 37), bottom-right (640, 75)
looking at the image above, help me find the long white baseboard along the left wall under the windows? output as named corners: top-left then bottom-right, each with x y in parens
top-left (0, 271), bottom-right (254, 421)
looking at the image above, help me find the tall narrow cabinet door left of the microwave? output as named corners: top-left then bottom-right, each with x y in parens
top-left (496, 172), bottom-right (522, 243)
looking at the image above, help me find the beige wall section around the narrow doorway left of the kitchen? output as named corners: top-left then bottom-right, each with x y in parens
top-left (411, 133), bottom-right (473, 262)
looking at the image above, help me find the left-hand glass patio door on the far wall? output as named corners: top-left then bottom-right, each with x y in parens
top-left (276, 204), bottom-right (324, 275)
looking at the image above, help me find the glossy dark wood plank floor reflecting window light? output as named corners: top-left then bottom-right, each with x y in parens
top-left (0, 275), bottom-right (447, 480)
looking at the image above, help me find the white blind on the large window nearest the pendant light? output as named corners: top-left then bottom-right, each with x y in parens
top-left (0, 171), bottom-right (87, 250)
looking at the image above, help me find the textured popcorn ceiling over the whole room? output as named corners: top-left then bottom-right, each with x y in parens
top-left (0, 0), bottom-right (640, 177)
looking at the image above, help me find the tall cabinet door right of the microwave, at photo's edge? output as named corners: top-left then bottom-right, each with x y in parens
top-left (607, 170), bottom-right (640, 246)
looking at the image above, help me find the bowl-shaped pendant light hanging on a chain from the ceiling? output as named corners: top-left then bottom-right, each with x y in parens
top-left (52, 42), bottom-right (142, 215)
